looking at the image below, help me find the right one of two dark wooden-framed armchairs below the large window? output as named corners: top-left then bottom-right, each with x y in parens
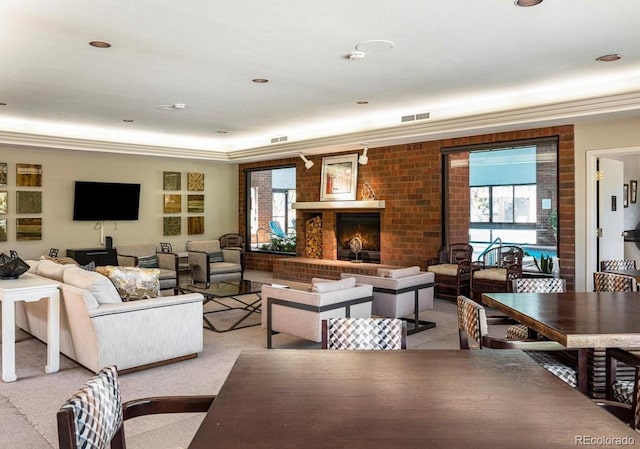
top-left (471, 245), bottom-right (524, 303)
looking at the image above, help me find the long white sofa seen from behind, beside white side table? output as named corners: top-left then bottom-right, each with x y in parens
top-left (16, 260), bottom-right (203, 372)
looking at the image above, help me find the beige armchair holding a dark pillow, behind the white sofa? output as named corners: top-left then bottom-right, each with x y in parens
top-left (116, 243), bottom-right (178, 290)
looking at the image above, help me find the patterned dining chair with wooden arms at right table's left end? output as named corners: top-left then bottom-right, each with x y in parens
top-left (457, 295), bottom-right (578, 388)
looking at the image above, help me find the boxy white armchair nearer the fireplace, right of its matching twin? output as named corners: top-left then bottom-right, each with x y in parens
top-left (341, 266), bottom-right (435, 334)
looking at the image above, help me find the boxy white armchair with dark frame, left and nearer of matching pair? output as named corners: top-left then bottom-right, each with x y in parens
top-left (262, 278), bottom-right (373, 349)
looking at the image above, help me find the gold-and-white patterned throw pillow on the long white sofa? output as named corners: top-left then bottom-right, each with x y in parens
top-left (96, 265), bottom-right (160, 301)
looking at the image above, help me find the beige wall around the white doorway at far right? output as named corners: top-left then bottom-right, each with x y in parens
top-left (575, 118), bottom-right (640, 291)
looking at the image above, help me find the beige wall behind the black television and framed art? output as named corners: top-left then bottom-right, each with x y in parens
top-left (0, 146), bottom-right (238, 258)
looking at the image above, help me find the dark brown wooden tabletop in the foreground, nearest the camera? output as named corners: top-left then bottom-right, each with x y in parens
top-left (189, 349), bottom-right (640, 449)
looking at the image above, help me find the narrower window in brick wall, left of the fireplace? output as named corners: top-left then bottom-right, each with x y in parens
top-left (246, 167), bottom-right (296, 253)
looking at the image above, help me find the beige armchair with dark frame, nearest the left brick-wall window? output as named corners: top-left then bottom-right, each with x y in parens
top-left (187, 240), bottom-right (243, 285)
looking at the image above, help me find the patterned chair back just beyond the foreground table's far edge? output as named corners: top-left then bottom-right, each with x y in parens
top-left (322, 318), bottom-right (407, 350)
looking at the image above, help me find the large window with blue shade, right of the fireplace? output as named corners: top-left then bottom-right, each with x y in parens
top-left (443, 138), bottom-right (558, 259)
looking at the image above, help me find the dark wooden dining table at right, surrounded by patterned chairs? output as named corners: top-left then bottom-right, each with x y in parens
top-left (482, 291), bottom-right (640, 394)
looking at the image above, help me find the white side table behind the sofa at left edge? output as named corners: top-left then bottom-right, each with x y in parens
top-left (0, 273), bottom-right (60, 382)
